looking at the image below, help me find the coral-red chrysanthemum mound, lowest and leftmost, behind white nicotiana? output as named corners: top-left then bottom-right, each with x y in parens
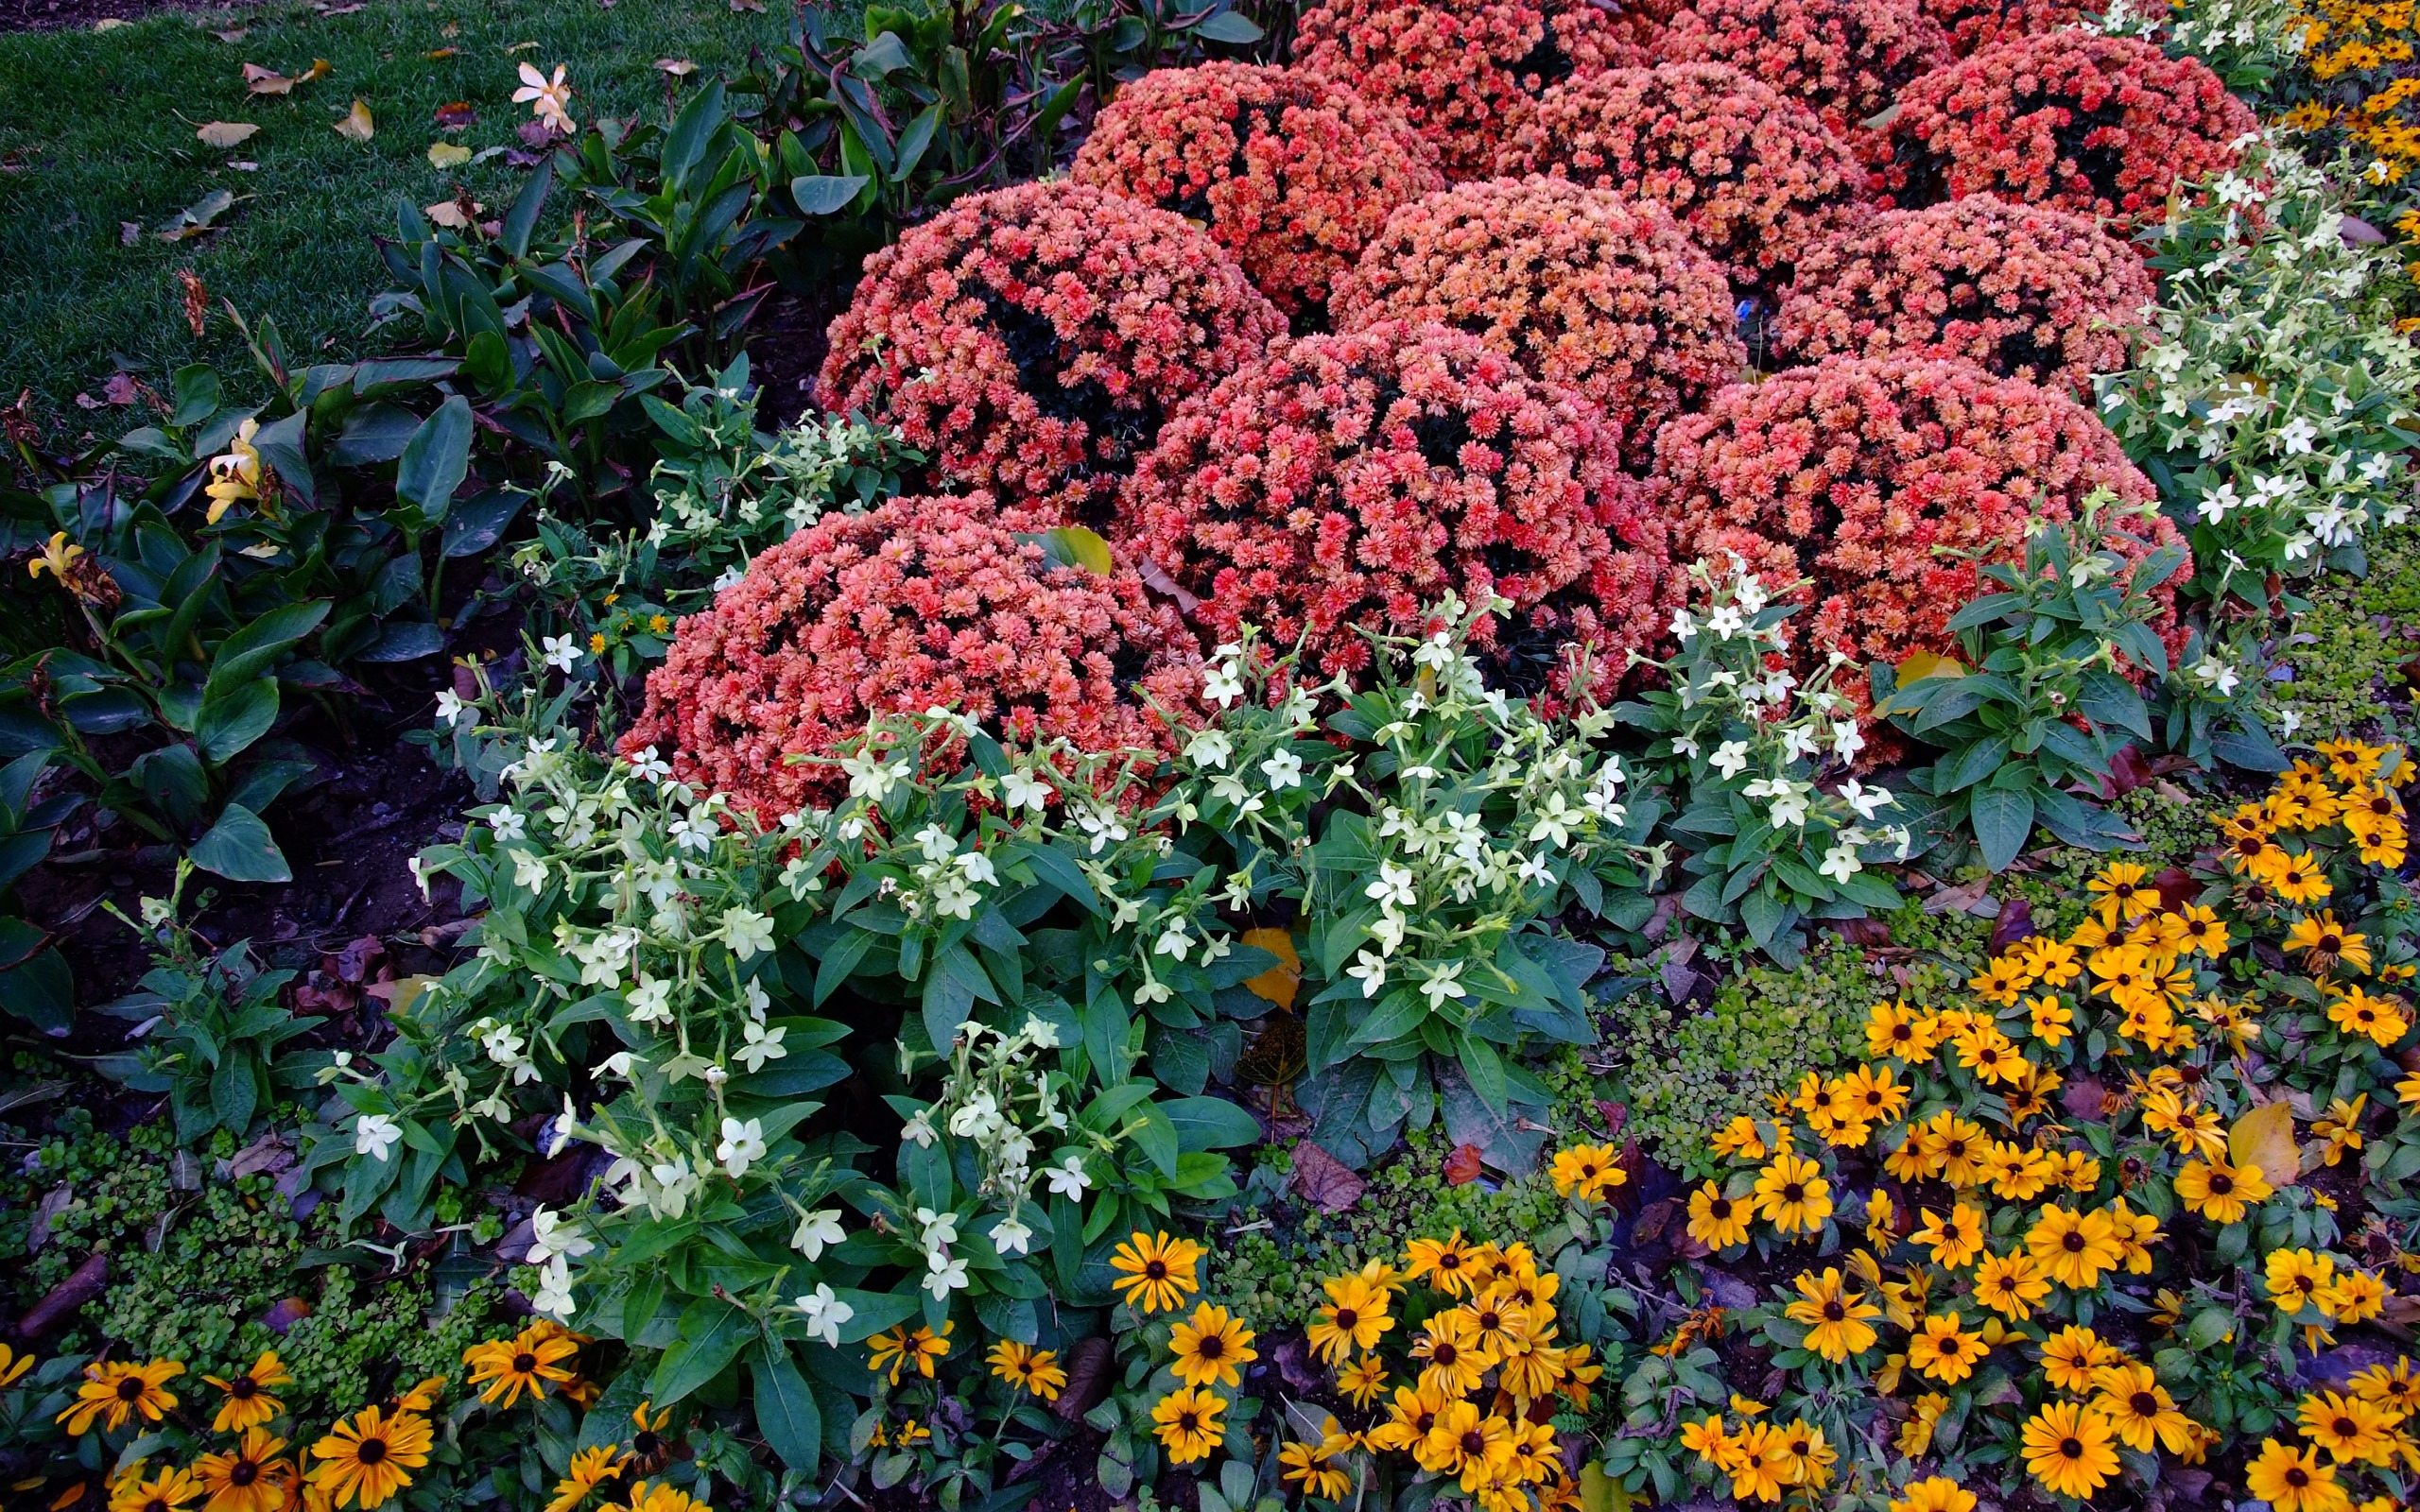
top-left (622, 493), bottom-right (1201, 825)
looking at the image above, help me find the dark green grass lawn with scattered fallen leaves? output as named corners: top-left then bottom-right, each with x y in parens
top-left (0, 0), bottom-right (786, 418)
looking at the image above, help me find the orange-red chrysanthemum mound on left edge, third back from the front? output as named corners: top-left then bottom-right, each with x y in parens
top-left (1075, 63), bottom-right (1444, 317)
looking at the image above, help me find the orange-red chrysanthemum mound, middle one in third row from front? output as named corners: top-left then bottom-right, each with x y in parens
top-left (1495, 63), bottom-right (1866, 290)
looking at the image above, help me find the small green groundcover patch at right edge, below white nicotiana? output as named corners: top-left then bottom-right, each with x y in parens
top-left (2274, 525), bottom-right (2420, 740)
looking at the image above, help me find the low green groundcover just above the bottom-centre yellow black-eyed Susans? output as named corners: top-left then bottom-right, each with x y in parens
top-left (1202, 1125), bottom-right (1564, 1333)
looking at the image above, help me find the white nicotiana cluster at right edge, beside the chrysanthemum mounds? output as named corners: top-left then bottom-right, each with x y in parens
top-left (2099, 138), bottom-right (2420, 597)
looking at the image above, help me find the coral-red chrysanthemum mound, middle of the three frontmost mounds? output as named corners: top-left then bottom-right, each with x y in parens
top-left (1123, 321), bottom-right (1665, 687)
